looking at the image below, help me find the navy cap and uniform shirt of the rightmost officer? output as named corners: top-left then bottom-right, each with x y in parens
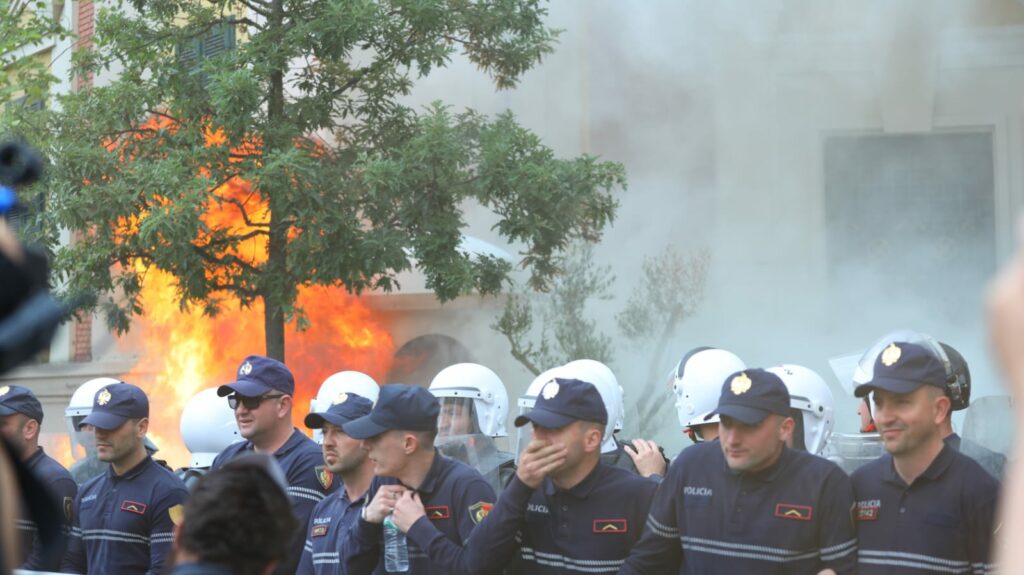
top-left (853, 342), bottom-right (999, 575)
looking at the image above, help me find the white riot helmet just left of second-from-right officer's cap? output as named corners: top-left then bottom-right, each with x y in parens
top-left (671, 347), bottom-right (746, 431)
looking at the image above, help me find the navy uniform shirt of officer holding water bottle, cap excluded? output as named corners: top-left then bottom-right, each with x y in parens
top-left (341, 451), bottom-right (495, 575)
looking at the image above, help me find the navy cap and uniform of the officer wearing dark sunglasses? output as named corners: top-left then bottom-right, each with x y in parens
top-left (210, 355), bottom-right (338, 575)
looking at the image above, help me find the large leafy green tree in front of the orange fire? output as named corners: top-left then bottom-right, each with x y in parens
top-left (29, 0), bottom-right (626, 358)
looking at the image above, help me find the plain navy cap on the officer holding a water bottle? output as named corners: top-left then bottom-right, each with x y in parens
top-left (341, 384), bottom-right (441, 439)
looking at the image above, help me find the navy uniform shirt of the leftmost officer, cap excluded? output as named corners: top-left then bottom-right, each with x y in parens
top-left (17, 447), bottom-right (78, 571)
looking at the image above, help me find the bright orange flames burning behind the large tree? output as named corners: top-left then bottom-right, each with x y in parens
top-left (100, 121), bottom-right (394, 468)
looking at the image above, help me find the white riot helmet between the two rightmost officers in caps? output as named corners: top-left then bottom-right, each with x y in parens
top-left (768, 363), bottom-right (836, 455)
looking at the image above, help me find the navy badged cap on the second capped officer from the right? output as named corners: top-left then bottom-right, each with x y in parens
top-left (705, 369), bottom-right (792, 426)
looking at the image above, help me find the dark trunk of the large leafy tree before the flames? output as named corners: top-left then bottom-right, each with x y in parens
top-left (260, 0), bottom-right (295, 362)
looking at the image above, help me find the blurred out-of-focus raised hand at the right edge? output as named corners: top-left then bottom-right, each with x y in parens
top-left (988, 216), bottom-right (1024, 396)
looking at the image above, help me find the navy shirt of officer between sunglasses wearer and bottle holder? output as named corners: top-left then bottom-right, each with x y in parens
top-left (296, 486), bottom-right (367, 575)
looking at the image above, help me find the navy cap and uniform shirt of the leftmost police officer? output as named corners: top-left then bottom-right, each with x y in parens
top-left (0, 386), bottom-right (78, 571)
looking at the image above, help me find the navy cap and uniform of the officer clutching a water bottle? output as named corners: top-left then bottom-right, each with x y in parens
top-left (341, 384), bottom-right (496, 575)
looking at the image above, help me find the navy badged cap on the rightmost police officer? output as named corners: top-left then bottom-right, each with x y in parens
top-left (853, 342), bottom-right (946, 397)
